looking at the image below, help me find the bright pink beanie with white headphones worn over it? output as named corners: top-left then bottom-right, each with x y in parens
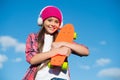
top-left (38, 6), bottom-right (63, 26)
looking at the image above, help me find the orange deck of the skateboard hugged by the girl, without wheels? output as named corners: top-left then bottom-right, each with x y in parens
top-left (50, 24), bottom-right (74, 66)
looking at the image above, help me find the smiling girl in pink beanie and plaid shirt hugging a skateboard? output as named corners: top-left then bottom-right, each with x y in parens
top-left (23, 6), bottom-right (89, 80)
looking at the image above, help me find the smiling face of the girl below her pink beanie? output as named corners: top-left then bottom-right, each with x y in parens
top-left (43, 17), bottom-right (60, 34)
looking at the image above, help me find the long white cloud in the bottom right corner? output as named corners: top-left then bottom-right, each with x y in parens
top-left (97, 68), bottom-right (120, 79)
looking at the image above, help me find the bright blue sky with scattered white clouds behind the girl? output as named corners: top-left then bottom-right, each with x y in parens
top-left (0, 0), bottom-right (120, 80)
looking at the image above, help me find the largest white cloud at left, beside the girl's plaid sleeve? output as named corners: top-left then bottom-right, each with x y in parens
top-left (0, 36), bottom-right (25, 52)
